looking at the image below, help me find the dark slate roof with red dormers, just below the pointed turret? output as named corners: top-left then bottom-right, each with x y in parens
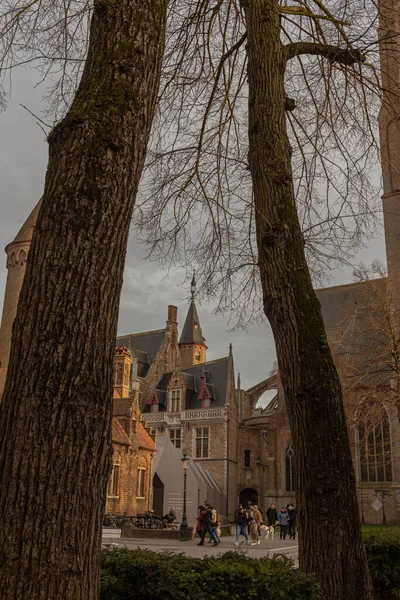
top-left (184, 356), bottom-right (230, 409)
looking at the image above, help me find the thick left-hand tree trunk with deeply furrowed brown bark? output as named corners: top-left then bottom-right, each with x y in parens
top-left (0, 0), bottom-right (167, 600)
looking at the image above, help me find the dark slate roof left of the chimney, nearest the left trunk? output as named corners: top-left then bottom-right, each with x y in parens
top-left (115, 329), bottom-right (166, 377)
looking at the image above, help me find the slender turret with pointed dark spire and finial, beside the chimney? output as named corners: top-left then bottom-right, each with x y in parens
top-left (179, 275), bottom-right (207, 369)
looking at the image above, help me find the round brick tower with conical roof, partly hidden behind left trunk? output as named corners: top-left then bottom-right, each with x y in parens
top-left (0, 199), bottom-right (42, 395)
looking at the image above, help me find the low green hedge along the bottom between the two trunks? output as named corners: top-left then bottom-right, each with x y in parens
top-left (100, 548), bottom-right (321, 600)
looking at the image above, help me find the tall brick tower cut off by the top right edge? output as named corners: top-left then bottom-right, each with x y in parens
top-left (379, 0), bottom-right (400, 315)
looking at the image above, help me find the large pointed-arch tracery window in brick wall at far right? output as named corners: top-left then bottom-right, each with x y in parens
top-left (357, 400), bottom-right (393, 483)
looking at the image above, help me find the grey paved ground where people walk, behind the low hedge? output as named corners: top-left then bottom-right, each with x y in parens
top-left (103, 535), bottom-right (298, 566)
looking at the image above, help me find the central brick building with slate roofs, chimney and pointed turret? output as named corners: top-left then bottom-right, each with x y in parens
top-left (117, 279), bottom-right (237, 514)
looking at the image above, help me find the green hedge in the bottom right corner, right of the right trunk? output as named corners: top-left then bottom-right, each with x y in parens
top-left (364, 527), bottom-right (400, 600)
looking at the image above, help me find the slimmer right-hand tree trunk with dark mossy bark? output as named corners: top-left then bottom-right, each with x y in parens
top-left (245, 0), bottom-right (373, 600)
